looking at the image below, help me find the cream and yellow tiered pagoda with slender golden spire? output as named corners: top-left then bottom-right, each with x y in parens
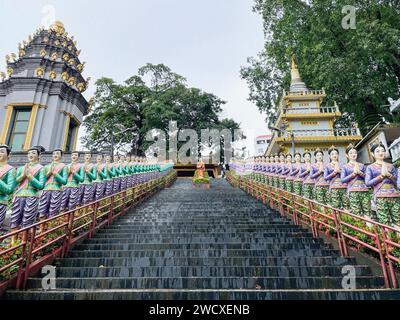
top-left (266, 57), bottom-right (362, 161)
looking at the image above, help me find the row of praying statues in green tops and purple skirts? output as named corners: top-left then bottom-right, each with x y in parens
top-left (0, 145), bottom-right (173, 230)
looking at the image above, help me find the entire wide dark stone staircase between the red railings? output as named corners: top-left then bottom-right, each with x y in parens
top-left (5, 179), bottom-right (400, 300)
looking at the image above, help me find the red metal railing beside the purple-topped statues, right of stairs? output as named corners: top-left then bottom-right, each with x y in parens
top-left (227, 172), bottom-right (400, 288)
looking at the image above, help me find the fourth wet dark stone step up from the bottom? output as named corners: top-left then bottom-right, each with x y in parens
top-left (56, 256), bottom-right (354, 267)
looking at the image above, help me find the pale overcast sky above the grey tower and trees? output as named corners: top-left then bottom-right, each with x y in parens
top-left (0, 0), bottom-right (267, 152)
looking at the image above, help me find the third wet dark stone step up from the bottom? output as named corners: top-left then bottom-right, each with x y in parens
top-left (52, 266), bottom-right (372, 278)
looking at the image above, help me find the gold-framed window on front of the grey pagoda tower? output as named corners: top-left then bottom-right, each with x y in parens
top-left (7, 107), bottom-right (32, 151)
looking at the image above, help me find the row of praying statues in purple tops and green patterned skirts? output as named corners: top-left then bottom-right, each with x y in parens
top-left (230, 143), bottom-right (400, 226)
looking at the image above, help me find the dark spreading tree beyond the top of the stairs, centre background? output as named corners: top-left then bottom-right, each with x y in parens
top-left (82, 63), bottom-right (239, 155)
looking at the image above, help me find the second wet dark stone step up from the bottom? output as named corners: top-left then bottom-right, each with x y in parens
top-left (27, 277), bottom-right (383, 289)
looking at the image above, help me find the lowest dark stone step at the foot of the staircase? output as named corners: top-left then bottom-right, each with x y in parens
top-left (5, 289), bottom-right (400, 301)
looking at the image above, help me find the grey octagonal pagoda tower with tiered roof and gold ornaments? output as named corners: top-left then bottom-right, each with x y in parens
top-left (0, 21), bottom-right (89, 153)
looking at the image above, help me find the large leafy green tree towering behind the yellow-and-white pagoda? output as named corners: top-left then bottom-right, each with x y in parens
top-left (241, 0), bottom-right (400, 133)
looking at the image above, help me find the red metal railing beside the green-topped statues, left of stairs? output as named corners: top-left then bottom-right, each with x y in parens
top-left (0, 171), bottom-right (176, 296)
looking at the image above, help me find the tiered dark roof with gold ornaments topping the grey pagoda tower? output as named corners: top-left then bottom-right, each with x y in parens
top-left (0, 21), bottom-right (90, 114)
